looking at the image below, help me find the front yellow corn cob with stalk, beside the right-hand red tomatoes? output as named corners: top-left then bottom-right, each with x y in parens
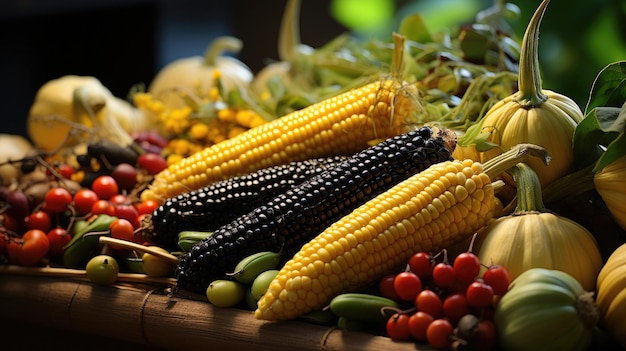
top-left (255, 144), bottom-right (534, 320)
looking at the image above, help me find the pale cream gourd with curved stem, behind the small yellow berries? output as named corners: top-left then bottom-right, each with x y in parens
top-left (148, 37), bottom-right (254, 108)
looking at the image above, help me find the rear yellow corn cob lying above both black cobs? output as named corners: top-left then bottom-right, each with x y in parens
top-left (141, 79), bottom-right (419, 202)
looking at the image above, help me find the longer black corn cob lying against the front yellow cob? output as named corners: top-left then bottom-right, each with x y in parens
top-left (176, 127), bottom-right (455, 293)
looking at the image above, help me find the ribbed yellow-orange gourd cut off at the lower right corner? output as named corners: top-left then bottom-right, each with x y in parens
top-left (596, 244), bottom-right (626, 348)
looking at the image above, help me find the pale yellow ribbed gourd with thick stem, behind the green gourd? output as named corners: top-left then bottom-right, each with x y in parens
top-left (475, 163), bottom-right (602, 291)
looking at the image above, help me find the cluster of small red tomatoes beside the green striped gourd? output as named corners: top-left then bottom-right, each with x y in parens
top-left (379, 250), bottom-right (510, 350)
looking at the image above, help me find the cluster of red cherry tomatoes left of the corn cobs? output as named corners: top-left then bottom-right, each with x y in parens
top-left (0, 143), bottom-right (167, 266)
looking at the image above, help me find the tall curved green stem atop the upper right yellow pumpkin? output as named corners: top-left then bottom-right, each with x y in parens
top-left (515, 0), bottom-right (550, 109)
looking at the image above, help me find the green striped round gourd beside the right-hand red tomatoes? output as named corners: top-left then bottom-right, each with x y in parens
top-left (494, 268), bottom-right (599, 351)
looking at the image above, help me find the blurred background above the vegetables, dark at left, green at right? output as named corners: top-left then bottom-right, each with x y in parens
top-left (0, 0), bottom-right (626, 140)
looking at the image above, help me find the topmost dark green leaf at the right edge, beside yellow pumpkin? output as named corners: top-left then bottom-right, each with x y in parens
top-left (585, 61), bottom-right (626, 115)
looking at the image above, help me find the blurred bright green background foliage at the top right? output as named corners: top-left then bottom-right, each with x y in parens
top-left (331, 0), bottom-right (626, 109)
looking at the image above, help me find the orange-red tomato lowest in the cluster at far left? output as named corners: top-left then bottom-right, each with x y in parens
top-left (7, 229), bottom-right (50, 266)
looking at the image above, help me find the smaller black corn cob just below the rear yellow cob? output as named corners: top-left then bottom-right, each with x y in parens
top-left (143, 156), bottom-right (348, 251)
